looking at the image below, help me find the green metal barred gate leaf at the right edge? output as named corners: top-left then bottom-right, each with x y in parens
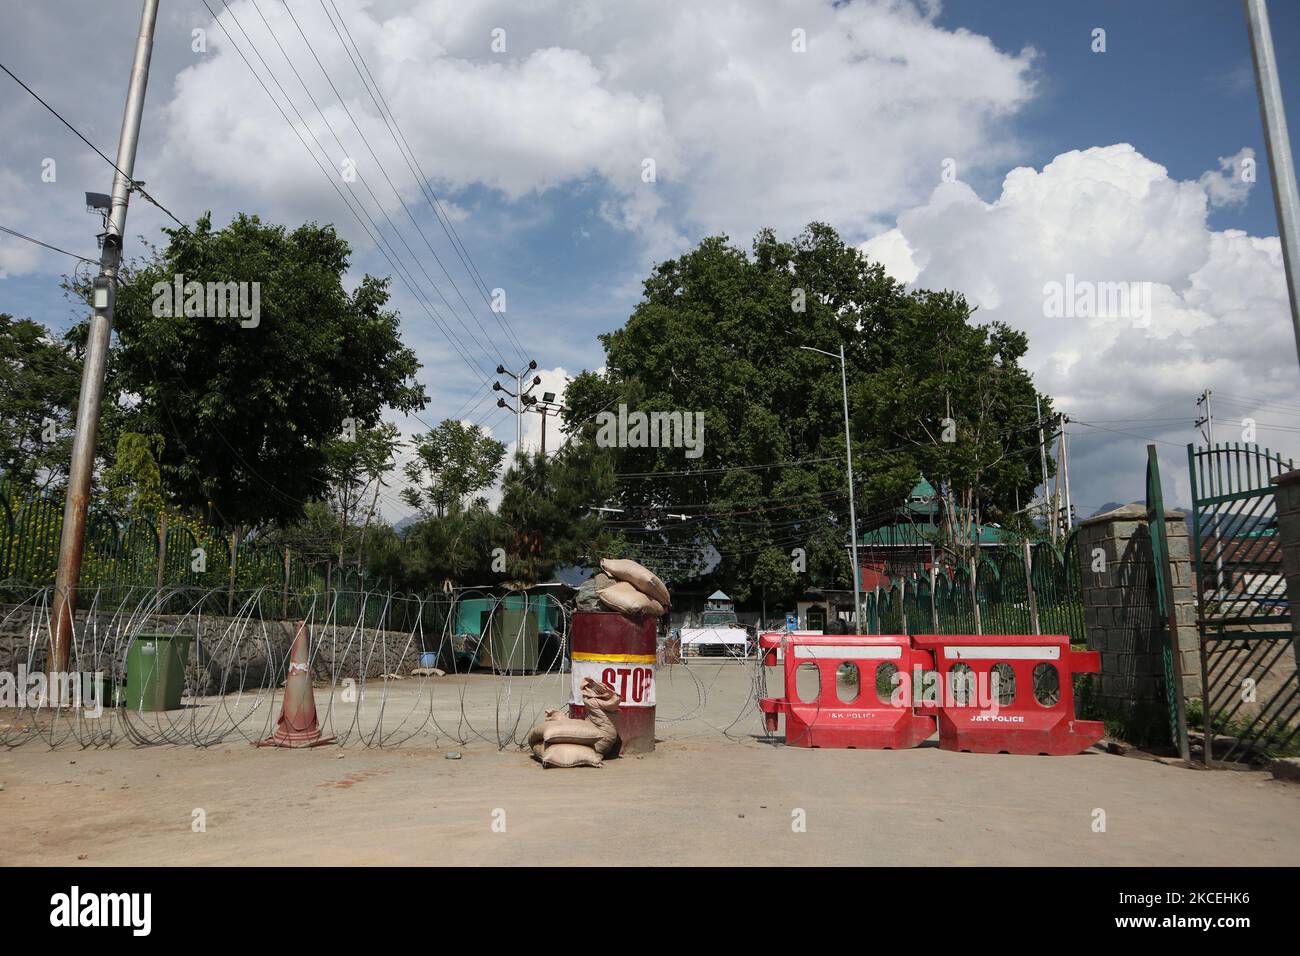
top-left (1187, 442), bottom-right (1300, 765)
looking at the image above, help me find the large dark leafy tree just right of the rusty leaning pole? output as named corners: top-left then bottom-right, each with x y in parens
top-left (114, 215), bottom-right (426, 527)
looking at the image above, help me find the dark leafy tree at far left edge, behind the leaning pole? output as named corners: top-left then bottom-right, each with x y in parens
top-left (0, 312), bottom-right (81, 488)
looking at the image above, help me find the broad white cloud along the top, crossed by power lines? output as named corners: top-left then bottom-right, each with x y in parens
top-left (144, 0), bottom-right (1035, 255)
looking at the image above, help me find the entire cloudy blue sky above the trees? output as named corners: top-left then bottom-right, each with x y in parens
top-left (0, 0), bottom-right (1300, 520)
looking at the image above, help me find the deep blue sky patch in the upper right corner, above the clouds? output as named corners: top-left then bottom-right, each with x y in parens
top-left (939, 0), bottom-right (1300, 235)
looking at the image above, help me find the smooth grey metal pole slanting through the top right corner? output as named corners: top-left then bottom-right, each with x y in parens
top-left (1244, 0), bottom-right (1300, 369)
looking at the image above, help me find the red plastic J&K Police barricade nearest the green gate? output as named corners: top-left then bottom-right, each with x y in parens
top-left (911, 635), bottom-right (1104, 754)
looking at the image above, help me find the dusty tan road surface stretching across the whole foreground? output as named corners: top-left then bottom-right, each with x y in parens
top-left (0, 665), bottom-right (1300, 865)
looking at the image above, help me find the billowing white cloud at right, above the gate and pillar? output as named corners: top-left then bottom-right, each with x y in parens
top-left (861, 143), bottom-right (1297, 505)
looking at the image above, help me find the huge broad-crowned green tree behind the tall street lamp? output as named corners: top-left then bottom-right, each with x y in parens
top-left (564, 224), bottom-right (1037, 601)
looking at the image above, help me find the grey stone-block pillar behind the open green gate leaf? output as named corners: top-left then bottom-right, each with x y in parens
top-left (1078, 505), bottom-right (1201, 744)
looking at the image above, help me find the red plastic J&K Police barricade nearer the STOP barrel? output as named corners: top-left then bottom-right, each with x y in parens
top-left (758, 632), bottom-right (935, 750)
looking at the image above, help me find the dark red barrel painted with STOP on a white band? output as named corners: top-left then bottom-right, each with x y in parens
top-left (569, 611), bottom-right (657, 753)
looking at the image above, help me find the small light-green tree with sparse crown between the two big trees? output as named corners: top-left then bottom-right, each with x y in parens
top-left (402, 419), bottom-right (506, 518)
